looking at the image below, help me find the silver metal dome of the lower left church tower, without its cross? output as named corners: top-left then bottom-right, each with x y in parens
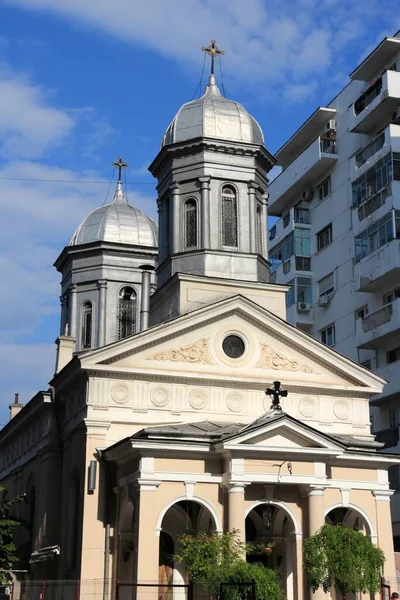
top-left (69, 183), bottom-right (157, 247)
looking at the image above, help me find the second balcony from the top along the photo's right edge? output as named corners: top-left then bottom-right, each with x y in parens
top-left (350, 123), bottom-right (400, 181)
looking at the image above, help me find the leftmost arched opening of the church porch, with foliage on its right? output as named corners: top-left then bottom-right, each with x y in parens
top-left (158, 499), bottom-right (217, 600)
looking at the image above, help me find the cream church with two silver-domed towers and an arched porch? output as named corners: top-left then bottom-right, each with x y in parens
top-left (0, 48), bottom-right (398, 600)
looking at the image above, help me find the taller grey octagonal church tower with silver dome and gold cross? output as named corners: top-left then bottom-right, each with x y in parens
top-left (150, 40), bottom-right (275, 286)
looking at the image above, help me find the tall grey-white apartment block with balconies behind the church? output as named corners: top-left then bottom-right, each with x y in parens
top-left (269, 32), bottom-right (400, 550)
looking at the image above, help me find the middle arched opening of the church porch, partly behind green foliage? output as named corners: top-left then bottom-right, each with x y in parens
top-left (246, 502), bottom-right (296, 600)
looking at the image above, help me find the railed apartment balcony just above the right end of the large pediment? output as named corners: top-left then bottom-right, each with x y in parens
top-left (356, 298), bottom-right (400, 350)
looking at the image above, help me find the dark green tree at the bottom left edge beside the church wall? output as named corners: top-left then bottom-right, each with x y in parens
top-left (0, 488), bottom-right (24, 585)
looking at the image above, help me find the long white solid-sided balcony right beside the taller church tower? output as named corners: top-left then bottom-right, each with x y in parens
top-left (268, 137), bottom-right (337, 216)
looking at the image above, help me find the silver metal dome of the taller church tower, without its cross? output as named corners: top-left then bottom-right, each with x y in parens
top-left (161, 75), bottom-right (264, 146)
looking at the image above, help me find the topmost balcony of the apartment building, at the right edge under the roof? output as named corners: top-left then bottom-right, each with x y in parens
top-left (349, 71), bottom-right (400, 133)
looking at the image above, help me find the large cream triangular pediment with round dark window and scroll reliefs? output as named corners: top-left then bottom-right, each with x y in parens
top-left (80, 296), bottom-right (382, 394)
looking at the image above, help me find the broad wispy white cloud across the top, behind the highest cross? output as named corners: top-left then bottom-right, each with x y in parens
top-left (5, 0), bottom-right (396, 100)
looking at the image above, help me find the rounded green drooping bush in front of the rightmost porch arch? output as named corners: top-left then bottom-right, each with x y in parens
top-left (304, 523), bottom-right (385, 596)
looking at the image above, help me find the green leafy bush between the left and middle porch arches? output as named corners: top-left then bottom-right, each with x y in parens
top-left (173, 531), bottom-right (284, 600)
